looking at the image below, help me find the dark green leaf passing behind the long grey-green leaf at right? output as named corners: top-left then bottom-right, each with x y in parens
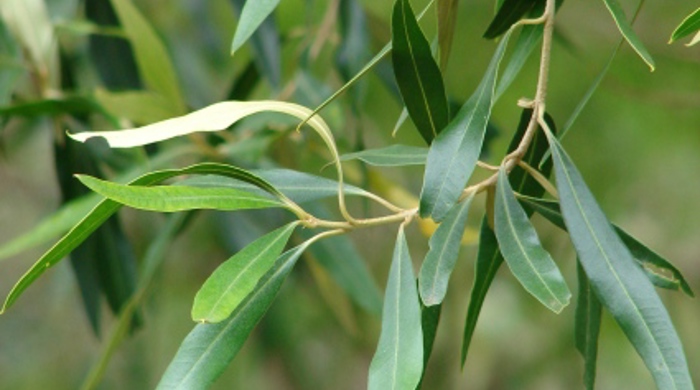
top-left (520, 196), bottom-right (695, 297)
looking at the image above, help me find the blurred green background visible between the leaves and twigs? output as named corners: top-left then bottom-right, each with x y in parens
top-left (0, 0), bottom-right (700, 390)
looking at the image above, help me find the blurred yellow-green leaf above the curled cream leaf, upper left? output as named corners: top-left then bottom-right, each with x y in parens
top-left (111, 0), bottom-right (185, 111)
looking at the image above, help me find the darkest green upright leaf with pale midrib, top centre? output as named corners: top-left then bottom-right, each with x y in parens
top-left (391, 0), bottom-right (449, 144)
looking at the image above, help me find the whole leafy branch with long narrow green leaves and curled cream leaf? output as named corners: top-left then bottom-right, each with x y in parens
top-left (0, 0), bottom-right (700, 389)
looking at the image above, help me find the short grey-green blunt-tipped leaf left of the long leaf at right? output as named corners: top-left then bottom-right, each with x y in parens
top-left (495, 168), bottom-right (571, 313)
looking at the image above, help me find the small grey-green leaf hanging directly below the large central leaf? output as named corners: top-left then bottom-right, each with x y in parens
top-left (418, 195), bottom-right (473, 306)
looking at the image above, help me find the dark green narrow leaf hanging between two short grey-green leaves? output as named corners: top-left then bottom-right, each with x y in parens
top-left (462, 216), bottom-right (503, 367)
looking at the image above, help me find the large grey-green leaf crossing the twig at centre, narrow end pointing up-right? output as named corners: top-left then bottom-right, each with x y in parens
top-left (420, 33), bottom-right (510, 222)
